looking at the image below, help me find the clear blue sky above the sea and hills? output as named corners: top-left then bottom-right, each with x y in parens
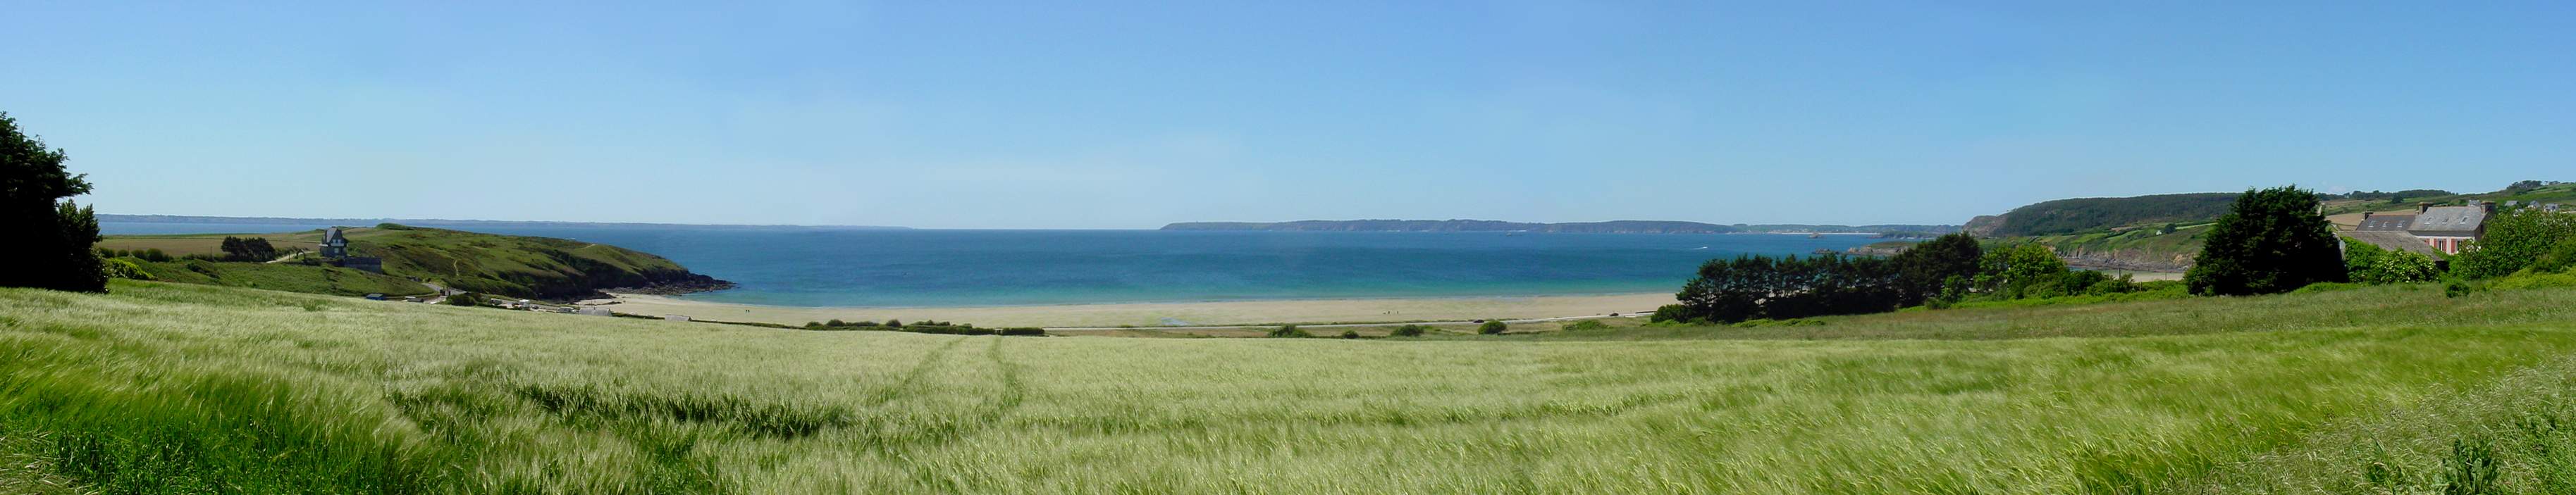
top-left (0, 3), bottom-right (2576, 227)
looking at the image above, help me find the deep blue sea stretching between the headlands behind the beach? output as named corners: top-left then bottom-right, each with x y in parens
top-left (101, 222), bottom-right (1878, 307)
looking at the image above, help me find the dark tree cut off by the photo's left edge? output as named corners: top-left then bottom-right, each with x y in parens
top-left (0, 113), bottom-right (109, 292)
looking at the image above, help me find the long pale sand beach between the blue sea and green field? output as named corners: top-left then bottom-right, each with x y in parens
top-left (582, 294), bottom-right (1672, 327)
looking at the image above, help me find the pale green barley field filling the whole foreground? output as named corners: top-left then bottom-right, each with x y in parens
top-left (0, 281), bottom-right (2576, 492)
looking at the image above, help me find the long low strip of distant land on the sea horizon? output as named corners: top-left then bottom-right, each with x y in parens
top-left (1161, 219), bottom-right (1958, 234)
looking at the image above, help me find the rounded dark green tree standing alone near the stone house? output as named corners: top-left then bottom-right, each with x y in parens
top-left (2182, 186), bottom-right (2344, 296)
